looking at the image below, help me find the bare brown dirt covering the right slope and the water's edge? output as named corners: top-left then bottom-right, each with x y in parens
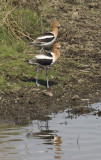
top-left (0, 0), bottom-right (101, 124)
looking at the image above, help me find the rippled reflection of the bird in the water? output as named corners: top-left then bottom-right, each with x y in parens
top-left (27, 121), bottom-right (63, 159)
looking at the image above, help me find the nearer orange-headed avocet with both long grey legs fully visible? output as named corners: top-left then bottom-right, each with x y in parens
top-left (28, 43), bottom-right (61, 88)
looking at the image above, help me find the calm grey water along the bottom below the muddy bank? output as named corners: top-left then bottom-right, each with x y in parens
top-left (0, 103), bottom-right (101, 160)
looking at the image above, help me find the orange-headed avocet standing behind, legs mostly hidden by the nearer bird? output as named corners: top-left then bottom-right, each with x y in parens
top-left (31, 21), bottom-right (60, 53)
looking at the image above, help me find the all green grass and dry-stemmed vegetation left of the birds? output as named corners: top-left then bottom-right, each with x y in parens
top-left (0, 0), bottom-right (52, 91)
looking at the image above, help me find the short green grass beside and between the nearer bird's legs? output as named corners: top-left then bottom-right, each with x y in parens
top-left (0, 41), bottom-right (58, 91)
